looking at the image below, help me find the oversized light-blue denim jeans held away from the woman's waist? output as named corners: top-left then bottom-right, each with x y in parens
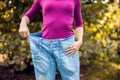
top-left (28, 32), bottom-right (80, 80)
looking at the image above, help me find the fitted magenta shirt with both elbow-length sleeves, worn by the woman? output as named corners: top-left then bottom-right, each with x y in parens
top-left (25, 0), bottom-right (83, 39)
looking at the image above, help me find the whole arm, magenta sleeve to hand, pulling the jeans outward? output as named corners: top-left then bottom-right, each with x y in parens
top-left (18, 0), bottom-right (41, 37)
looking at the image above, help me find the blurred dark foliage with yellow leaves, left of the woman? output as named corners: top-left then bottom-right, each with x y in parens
top-left (0, 0), bottom-right (41, 71)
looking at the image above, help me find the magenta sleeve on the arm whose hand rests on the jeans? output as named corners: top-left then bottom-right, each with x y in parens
top-left (74, 0), bottom-right (83, 28)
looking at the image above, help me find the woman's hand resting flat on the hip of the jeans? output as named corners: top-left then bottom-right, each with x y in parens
top-left (66, 41), bottom-right (82, 55)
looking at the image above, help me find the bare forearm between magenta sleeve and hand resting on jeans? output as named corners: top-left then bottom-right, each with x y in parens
top-left (75, 27), bottom-right (84, 43)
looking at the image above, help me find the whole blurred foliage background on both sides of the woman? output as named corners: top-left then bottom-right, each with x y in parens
top-left (0, 0), bottom-right (120, 80)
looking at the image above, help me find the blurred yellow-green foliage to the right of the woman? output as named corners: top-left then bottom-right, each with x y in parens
top-left (80, 3), bottom-right (120, 80)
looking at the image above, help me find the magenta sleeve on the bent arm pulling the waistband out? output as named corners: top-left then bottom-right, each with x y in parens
top-left (24, 0), bottom-right (41, 21)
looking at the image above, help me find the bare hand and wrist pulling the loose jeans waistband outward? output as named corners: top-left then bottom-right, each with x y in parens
top-left (18, 16), bottom-right (30, 37)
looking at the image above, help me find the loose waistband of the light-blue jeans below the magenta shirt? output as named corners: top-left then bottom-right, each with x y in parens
top-left (29, 32), bottom-right (75, 43)
